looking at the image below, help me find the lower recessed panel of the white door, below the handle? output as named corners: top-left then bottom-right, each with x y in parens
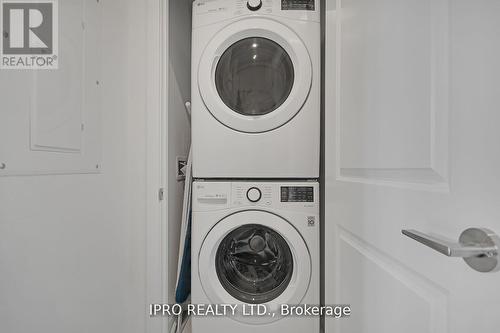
top-left (336, 227), bottom-right (448, 333)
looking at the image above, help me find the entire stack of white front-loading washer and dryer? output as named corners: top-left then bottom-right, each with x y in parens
top-left (191, 0), bottom-right (321, 333)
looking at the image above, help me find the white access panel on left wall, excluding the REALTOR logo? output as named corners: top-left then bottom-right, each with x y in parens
top-left (0, 0), bottom-right (103, 176)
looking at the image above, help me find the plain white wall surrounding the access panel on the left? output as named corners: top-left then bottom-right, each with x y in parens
top-left (0, 0), bottom-right (147, 333)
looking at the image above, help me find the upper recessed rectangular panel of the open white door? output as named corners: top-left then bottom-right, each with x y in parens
top-left (336, 0), bottom-right (449, 190)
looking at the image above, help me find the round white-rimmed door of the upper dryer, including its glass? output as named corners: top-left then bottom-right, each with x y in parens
top-left (198, 18), bottom-right (312, 133)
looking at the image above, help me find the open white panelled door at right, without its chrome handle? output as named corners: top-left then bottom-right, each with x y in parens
top-left (325, 0), bottom-right (500, 333)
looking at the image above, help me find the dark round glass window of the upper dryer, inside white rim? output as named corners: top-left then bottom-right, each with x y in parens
top-left (215, 37), bottom-right (294, 116)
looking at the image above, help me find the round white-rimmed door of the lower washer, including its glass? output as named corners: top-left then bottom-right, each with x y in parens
top-left (198, 210), bottom-right (311, 323)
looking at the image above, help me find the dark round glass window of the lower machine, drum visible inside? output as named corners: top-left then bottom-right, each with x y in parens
top-left (215, 224), bottom-right (293, 304)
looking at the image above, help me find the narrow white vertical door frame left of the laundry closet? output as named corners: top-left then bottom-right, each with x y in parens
top-left (144, 0), bottom-right (169, 333)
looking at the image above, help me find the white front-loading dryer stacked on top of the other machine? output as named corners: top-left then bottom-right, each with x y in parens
top-left (191, 0), bottom-right (321, 179)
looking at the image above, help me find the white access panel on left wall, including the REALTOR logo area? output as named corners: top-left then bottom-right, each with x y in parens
top-left (0, 0), bottom-right (102, 176)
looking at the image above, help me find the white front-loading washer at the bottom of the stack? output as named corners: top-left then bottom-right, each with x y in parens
top-left (191, 181), bottom-right (320, 333)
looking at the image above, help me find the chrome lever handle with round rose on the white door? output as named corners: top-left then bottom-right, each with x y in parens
top-left (401, 228), bottom-right (500, 273)
